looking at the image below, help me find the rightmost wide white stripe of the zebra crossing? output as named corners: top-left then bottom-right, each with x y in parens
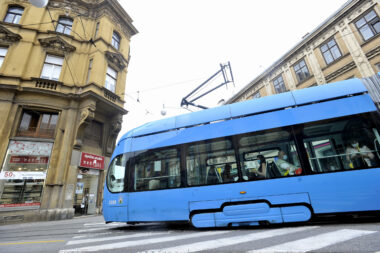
top-left (249, 229), bottom-right (377, 253)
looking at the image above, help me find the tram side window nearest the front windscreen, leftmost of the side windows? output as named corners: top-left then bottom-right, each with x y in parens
top-left (134, 148), bottom-right (181, 191)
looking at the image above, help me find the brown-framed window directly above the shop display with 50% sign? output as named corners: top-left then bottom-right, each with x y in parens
top-left (17, 110), bottom-right (58, 138)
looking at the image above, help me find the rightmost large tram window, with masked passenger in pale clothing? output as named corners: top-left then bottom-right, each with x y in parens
top-left (304, 115), bottom-right (380, 173)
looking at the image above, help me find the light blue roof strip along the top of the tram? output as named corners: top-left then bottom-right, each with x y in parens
top-left (121, 78), bottom-right (367, 140)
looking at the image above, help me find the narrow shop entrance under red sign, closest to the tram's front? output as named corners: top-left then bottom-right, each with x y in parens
top-left (74, 152), bottom-right (104, 214)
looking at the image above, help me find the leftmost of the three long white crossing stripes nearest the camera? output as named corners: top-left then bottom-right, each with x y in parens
top-left (59, 231), bottom-right (230, 253)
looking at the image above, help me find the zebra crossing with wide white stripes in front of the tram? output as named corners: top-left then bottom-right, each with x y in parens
top-left (59, 223), bottom-right (380, 253)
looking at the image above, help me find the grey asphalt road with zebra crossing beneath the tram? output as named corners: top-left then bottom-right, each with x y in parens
top-left (0, 216), bottom-right (380, 253)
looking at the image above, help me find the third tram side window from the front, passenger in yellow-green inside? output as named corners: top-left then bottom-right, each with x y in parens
top-left (239, 130), bottom-right (302, 180)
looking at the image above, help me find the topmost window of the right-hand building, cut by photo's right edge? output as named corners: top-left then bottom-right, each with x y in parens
top-left (355, 10), bottom-right (380, 40)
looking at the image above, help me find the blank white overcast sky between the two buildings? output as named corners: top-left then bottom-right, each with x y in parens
top-left (119, 0), bottom-right (346, 137)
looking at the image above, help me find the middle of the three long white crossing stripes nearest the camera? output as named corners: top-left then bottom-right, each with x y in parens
top-left (152, 226), bottom-right (318, 253)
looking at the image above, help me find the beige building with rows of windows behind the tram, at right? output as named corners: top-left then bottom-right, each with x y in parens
top-left (227, 0), bottom-right (380, 103)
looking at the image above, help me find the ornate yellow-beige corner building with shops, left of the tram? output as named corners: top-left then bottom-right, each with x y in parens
top-left (0, 0), bottom-right (137, 223)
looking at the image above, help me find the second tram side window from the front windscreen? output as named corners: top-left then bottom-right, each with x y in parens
top-left (186, 139), bottom-right (238, 186)
